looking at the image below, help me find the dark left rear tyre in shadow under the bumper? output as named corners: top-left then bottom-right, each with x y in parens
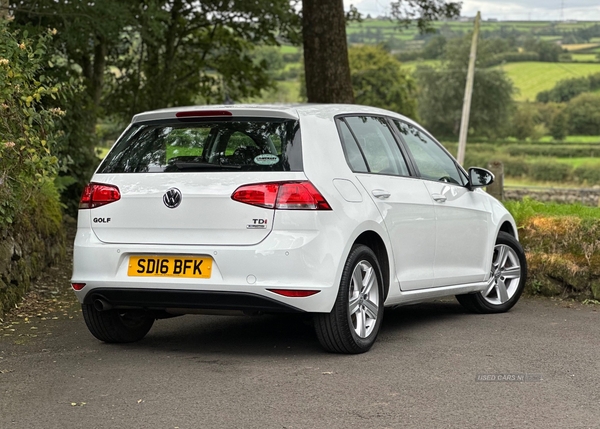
top-left (81, 304), bottom-right (154, 343)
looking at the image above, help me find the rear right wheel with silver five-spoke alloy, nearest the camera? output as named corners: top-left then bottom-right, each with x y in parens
top-left (314, 244), bottom-right (384, 354)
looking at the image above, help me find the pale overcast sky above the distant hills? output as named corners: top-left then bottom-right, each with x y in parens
top-left (344, 0), bottom-right (600, 21)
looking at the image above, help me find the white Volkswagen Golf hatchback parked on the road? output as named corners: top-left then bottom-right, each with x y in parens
top-left (72, 105), bottom-right (527, 353)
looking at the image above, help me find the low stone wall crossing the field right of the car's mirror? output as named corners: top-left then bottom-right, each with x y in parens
top-left (504, 186), bottom-right (600, 207)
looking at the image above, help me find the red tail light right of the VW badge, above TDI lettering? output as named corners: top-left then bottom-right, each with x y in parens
top-left (231, 181), bottom-right (331, 210)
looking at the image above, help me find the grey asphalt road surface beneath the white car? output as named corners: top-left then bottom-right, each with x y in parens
top-left (0, 299), bottom-right (600, 429)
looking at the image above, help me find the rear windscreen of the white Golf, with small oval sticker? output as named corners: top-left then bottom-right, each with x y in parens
top-left (98, 118), bottom-right (302, 173)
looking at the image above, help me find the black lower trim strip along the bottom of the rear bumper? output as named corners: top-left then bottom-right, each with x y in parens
top-left (83, 288), bottom-right (303, 313)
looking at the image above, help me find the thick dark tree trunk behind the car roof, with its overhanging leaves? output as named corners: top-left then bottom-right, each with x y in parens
top-left (302, 0), bottom-right (460, 103)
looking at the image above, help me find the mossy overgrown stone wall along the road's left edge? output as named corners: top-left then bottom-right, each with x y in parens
top-left (0, 229), bottom-right (65, 318)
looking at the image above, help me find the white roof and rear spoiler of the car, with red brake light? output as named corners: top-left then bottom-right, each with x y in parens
top-left (132, 104), bottom-right (412, 123)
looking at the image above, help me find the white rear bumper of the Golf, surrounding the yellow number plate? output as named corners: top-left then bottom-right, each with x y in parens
top-left (71, 223), bottom-right (344, 313)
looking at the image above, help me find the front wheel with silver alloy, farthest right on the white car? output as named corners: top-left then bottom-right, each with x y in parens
top-left (456, 232), bottom-right (527, 313)
